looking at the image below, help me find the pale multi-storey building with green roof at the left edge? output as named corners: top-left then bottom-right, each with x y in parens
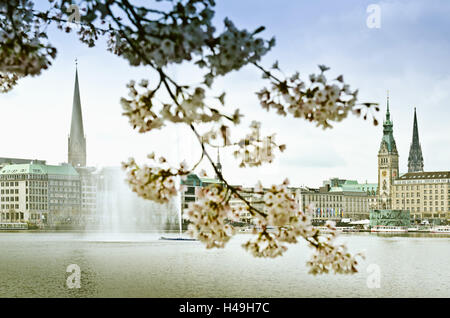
top-left (0, 163), bottom-right (81, 224)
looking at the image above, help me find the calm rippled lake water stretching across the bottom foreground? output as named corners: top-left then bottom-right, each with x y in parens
top-left (0, 232), bottom-right (450, 297)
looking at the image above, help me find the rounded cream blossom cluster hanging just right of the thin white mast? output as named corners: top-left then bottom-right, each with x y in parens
top-left (186, 184), bottom-right (239, 248)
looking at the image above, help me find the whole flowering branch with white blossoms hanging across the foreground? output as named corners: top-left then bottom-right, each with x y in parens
top-left (0, 0), bottom-right (378, 274)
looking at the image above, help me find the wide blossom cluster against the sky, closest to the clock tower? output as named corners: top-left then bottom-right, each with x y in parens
top-left (257, 65), bottom-right (370, 129)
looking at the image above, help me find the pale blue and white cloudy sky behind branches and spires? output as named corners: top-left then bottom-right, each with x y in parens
top-left (0, 0), bottom-right (450, 186)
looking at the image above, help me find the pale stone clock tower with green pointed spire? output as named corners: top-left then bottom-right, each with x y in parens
top-left (378, 95), bottom-right (398, 209)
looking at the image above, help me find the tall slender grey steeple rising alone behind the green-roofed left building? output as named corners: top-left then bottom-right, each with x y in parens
top-left (68, 60), bottom-right (86, 167)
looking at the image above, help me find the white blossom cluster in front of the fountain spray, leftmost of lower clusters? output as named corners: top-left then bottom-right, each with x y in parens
top-left (122, 154), bottom-right (189, 203)
